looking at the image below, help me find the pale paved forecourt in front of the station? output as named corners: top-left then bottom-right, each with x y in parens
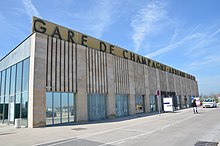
top-left (0, 108), bottom-right (220, 146)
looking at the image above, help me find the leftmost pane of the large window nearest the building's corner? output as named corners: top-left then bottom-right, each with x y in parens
top-left (46, 92), bottom-right (53, 125)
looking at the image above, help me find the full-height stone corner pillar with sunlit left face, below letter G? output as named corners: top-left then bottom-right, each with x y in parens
top-left (28, 33), bottom-right (47, 128)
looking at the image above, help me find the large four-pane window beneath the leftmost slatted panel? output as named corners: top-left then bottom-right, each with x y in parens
top-left (46, 92), bottom-right (75, 125)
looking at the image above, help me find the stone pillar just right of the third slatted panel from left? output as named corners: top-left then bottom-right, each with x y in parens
top-left (128, 60), bottom-right (136, 115)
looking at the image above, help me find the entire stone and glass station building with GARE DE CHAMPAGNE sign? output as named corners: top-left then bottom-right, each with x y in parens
top-left (0, 17), bottom-right (198, 128)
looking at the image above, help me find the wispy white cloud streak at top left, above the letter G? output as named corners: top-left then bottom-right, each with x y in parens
top-left (22, 0), bottom-right (41, 19)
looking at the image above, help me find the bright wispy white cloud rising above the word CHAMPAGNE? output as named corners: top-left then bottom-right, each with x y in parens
top-left (130, 1), bottom-right (168, 52)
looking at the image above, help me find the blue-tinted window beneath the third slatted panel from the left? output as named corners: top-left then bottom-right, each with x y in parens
top-left (115, 94), bottom-right (128, 117)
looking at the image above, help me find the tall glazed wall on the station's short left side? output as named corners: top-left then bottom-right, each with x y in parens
top-left (0, 58), bottom-right (29, 126)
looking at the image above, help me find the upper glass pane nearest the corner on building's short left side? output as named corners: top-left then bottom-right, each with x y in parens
top-left (22, 59), bottom-right (29, 91)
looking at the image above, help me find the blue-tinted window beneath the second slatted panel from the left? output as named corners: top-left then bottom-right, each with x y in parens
top-left (88, 93), bottom-right (106, 121)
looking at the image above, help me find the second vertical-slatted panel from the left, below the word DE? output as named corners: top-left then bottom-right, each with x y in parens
top-left (86, 48), bottom-right (108, 94)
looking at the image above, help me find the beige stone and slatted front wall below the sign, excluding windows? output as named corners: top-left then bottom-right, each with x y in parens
top-left (23, 33), bottom-right (198, 127)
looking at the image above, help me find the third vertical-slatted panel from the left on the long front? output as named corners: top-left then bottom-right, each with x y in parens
top-left (113, 56), bottom-right (130, 94)
